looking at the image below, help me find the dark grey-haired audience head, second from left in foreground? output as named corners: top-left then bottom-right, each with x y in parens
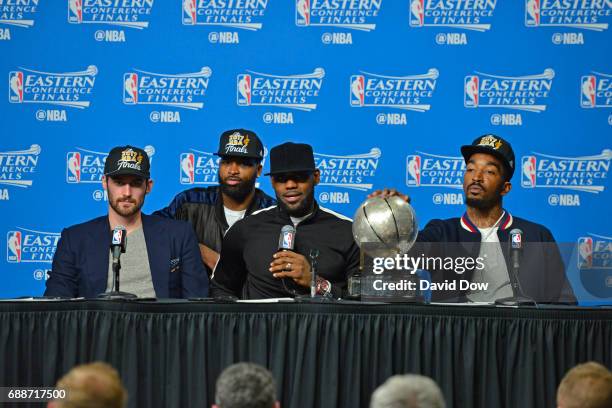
top-left (213, 363), bottom-right (280, 408)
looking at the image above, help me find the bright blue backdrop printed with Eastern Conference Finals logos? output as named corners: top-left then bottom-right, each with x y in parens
top-left (0, 0), bottom-right (612, 303)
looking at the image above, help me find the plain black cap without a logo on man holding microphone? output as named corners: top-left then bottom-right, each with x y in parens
top-left (264, 142), bottom-right (317, 176)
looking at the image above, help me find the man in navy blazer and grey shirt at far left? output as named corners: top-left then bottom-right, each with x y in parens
top-left (45, 146), bottom-right (208, 298)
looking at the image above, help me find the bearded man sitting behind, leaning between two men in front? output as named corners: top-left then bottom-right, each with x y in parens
top-left (155, 129), bottom-right (276, 276)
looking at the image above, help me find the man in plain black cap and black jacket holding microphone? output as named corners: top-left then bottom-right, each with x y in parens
top-left (211, 142), bottom-right (359, 299)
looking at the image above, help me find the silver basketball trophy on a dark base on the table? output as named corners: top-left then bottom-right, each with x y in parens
top-left (348, 196), bottom-right (418, 300)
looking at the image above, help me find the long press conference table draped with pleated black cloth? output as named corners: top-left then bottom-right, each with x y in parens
top-left (0, 300), bottom-right (612, 408)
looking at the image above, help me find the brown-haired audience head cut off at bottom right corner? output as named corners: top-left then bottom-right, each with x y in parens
top-left (557, 361), bottom-right (612, 408)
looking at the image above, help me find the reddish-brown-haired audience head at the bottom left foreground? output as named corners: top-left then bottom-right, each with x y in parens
top-left (56, 362), bottom-right (127, 408)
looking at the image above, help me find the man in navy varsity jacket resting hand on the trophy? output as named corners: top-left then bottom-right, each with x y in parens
top-left (372, 134), bottom-right (576, 303)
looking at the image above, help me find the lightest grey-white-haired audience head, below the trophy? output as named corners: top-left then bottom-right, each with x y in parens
top-left (370, 374), bottom-right (446, 408)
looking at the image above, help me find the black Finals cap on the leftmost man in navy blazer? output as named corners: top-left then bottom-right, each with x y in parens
top-left (104, 146), bottom-right (151, 179)
